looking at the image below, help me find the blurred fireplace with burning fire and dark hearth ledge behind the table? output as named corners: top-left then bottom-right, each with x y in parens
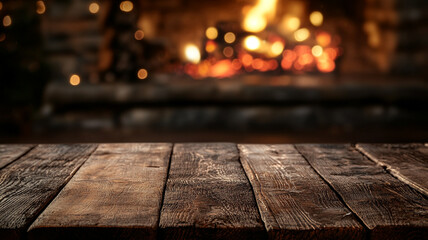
top-left (22, 0), bottom-right (428, 141)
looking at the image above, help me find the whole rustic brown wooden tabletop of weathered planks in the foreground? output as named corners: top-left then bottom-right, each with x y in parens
top-left (0, 143), bottom-right (428, 239)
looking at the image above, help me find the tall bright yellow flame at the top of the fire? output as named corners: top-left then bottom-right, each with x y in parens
top-left (242, 0), bottom-right (277, 32)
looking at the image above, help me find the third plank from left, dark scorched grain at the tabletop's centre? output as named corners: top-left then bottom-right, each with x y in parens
top-left (159, 143), bottom-right (265, 239)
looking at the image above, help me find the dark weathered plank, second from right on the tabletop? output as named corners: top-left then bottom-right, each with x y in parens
top-left (296, 144), bottom-right (428, 239)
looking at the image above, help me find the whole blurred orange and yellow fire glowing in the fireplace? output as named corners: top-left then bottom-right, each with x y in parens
top-left (179, 0), bottom-right (342, 79)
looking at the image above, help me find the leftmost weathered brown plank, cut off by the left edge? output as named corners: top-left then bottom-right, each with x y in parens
top-left (0, 144), bottom-right (96, 239)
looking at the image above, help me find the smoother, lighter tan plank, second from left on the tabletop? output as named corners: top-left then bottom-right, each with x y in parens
top-left (29, 143), bottom-right (172, 239)
